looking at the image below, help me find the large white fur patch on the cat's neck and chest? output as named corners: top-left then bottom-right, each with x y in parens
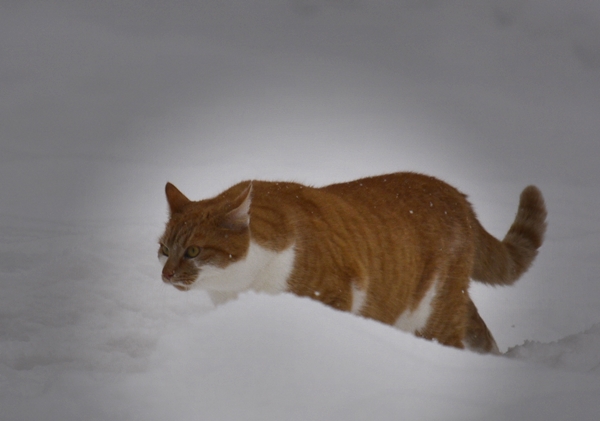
top-left (192, 241), bottom-right (295, 304)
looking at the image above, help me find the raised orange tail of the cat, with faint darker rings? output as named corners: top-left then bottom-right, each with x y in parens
top-left (471, 186), bottom-right (547, 285)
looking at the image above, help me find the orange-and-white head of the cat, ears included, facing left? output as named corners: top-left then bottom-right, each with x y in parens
top-left (158, 182), bottom-right (252, 291)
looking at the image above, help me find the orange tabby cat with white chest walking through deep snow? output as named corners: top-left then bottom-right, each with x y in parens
top-left (158, 172), bottom-right (547, 353)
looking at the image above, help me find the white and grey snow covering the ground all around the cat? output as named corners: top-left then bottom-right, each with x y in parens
top-left (0, 0), bottom-right (600, 421)
